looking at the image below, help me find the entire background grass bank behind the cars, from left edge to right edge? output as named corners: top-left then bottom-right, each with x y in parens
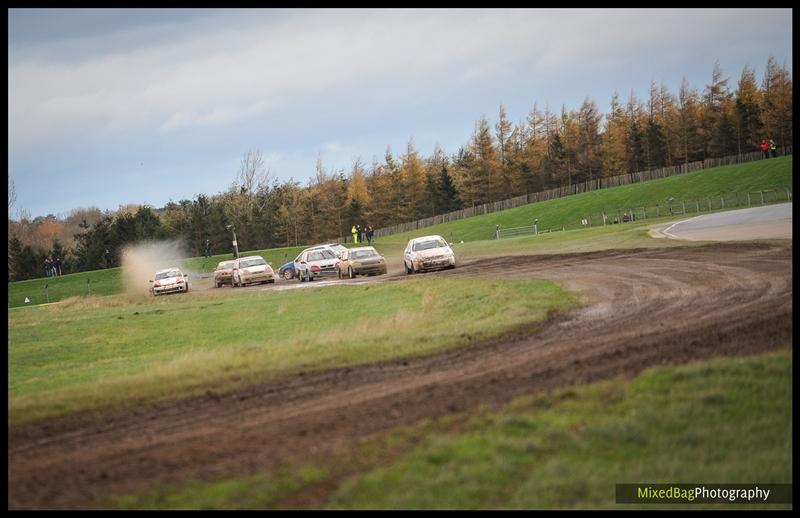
top-left (8, 156), bottom-right (792, 308)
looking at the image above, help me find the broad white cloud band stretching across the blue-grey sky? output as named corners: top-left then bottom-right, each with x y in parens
top-left (9, 9), bottom-right (792, 156)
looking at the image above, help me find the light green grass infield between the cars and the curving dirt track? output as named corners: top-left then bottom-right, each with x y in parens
top-left (8, 277), bottom-right (578, 423)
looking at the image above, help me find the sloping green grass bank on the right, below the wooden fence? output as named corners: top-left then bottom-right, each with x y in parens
top-left (378, 156), bottom-right (792, 246)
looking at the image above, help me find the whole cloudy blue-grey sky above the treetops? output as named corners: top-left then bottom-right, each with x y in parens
top-left (8, 8), bottom-right (792, 217)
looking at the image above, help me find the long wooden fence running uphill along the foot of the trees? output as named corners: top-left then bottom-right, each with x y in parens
top-left (338, 146), bottom-right (792, 243)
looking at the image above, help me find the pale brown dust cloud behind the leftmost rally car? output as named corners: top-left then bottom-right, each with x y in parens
top-left (122, 240), bottom-right (188, 295)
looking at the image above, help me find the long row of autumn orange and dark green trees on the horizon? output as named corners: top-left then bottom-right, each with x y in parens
top-left (9, 58), bottom-right (793, 278)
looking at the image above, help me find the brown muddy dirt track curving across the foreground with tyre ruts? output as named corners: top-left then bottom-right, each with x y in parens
top-left (8, 244), bottom-right (792, 508)
